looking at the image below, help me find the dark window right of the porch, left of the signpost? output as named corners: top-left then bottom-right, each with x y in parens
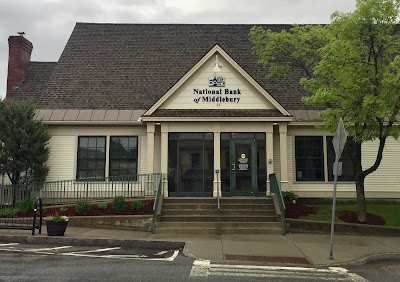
top-left (295, 136), bottom-right (324, 181)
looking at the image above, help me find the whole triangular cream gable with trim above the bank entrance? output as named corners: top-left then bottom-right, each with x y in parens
top-left (145, 44), bottom-right (290, 116)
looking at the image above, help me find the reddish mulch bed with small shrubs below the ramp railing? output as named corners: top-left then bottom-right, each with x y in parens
top-left (43, 200), bottom-right (154, 216)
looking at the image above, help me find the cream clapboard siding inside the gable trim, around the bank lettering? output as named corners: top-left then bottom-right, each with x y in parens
top-left (160, 56), bottom-right (275, 109)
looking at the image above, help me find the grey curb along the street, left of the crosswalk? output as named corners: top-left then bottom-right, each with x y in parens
top-left (0, 235), bottom-right (185, 249)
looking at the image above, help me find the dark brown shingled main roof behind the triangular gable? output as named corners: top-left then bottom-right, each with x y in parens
top-left (8, 23), bottom-right (312, 110)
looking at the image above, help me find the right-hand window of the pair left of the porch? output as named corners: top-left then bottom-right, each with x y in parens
top-left (109, 136), bottom-right (138, 177)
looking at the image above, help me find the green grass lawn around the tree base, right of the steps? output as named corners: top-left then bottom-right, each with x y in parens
top-left (301, 204), bottom-right (400, 227)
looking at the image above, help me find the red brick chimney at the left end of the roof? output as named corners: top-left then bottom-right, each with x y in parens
top-left (6, 32), bottom-right (33, 96)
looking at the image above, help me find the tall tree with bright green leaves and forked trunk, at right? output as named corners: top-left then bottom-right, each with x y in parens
top-left (250, 0), bottom-right (400, 222)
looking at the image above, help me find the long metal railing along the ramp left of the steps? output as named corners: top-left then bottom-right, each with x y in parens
top-left (0, 173), bottom-right (161, 205)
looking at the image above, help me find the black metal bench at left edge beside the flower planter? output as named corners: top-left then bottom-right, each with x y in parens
top-left (0, 197), bottom-right (43, 235)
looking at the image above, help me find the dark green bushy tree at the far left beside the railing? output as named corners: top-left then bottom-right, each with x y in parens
top-left (0, 100), bottom-right (50, 184)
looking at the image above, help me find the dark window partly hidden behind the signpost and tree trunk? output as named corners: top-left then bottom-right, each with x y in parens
top-left (326, 136), bottom-right (355, 181)
